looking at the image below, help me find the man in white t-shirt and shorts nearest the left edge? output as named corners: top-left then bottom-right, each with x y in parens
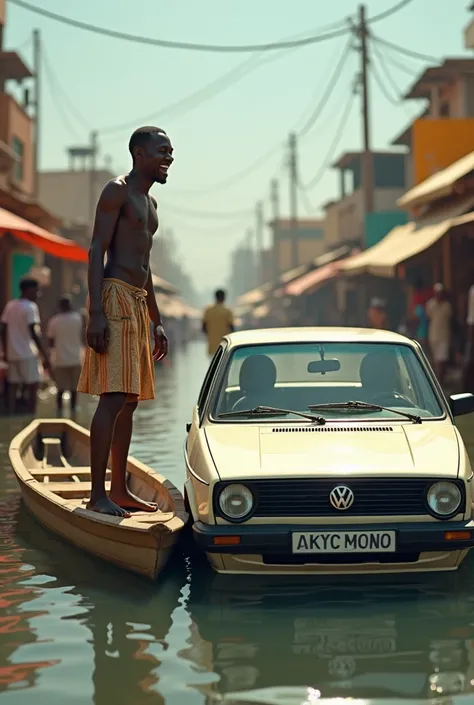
top-left (2, 279), bottom-right (51, 414)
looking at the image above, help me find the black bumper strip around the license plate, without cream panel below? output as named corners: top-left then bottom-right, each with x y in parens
top-left (193, 520), bottom-right (474, 563)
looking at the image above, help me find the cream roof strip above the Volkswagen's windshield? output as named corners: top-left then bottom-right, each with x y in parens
top-left (225, 327), bottom-right (415, 348)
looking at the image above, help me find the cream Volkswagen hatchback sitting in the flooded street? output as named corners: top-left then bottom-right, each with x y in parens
top-left (184, 328), bottom-right (474, 574)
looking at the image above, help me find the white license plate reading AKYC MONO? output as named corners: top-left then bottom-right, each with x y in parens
top-left (292, 531), bottom-right (396, 553)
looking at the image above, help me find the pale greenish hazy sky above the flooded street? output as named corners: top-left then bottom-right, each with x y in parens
top-left (5, 0), bottom-right (470, 289)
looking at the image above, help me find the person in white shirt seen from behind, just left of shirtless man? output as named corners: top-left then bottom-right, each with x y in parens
top-left (48, 296), bottom-right (84, 414)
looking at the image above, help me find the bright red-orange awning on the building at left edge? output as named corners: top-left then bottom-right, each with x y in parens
top-left (0, 208), bottom-right (88, 262)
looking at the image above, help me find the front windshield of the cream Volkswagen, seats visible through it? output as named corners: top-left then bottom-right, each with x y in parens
top-left (211, 342), bottom-right (444, 423)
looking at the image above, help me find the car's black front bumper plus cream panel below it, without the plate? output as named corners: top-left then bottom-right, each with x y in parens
top-left (193, 521), bottom-right (474, 575)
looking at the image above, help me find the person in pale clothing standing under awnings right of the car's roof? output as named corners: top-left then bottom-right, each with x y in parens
top-left (426, 282), bottom-right (453, 384)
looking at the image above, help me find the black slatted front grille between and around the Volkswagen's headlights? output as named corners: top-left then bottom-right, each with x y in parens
top-left (214, 477), bottom-right (466, 520)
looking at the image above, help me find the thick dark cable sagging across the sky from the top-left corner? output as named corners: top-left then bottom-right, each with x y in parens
top-left (9, 0), bottom-right (350, 53)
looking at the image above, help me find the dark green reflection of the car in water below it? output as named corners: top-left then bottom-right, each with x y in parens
top-left (184, 560), bottom-right (474, 705)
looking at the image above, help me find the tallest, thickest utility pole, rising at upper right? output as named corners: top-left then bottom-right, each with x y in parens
top-left (359, 5), bottom-right (374, 215)
